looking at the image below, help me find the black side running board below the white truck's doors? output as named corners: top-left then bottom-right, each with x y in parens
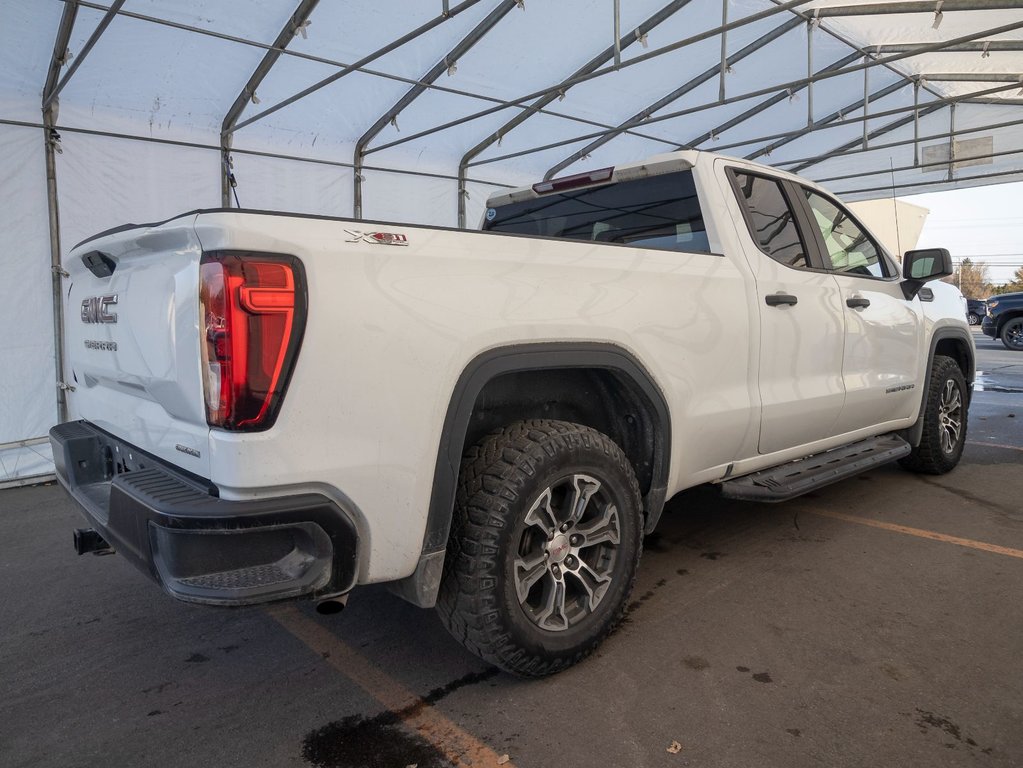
top-left (720, 435), bottom-right (913, 502)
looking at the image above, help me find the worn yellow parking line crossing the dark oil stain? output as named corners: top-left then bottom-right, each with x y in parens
top-left (266, 604), bottom-right (515, 768)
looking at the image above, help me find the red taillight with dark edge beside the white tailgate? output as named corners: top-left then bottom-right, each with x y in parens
top-left (199, 252), bottom-right (306, 431)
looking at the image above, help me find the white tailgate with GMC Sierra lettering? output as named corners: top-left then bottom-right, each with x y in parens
top-left (64, 215), bottom-right (210, 478)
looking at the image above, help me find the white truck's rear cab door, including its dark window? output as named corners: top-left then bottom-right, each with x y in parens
top-left (719, 161), bottom-right (846, 454)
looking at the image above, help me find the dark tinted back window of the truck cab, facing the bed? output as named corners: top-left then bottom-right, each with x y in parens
top-left (483, 171), bottom-right (710, 253)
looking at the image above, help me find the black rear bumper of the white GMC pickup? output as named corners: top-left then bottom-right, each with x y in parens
top-left (50, 421), bottom-right (359, 605)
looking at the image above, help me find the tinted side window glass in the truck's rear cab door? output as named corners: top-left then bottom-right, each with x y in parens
top-left (735, 172), bottom-right (810, 269)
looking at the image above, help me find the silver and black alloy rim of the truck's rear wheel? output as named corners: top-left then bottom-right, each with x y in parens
top-left (513, 473), bottom-right (621, 632)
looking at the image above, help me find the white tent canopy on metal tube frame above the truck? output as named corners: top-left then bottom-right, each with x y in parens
top-left (0, 0), bottom-right (1023, 484)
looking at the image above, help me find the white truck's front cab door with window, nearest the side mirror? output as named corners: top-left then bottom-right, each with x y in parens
top-left (797, 186), bottom-right (926, 434)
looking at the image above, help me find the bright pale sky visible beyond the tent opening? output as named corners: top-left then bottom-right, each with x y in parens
top-left (901, 181), bottom-right (1023, 284)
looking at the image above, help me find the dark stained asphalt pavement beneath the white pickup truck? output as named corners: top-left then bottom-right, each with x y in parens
top-left (0, 333), bottom-right (1023, 768)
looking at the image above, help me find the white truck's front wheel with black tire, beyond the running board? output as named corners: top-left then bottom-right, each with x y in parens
top-left (899, 355), bottom-right (969, 475)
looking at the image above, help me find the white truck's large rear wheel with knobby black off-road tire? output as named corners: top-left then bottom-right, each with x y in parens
top-left (437, 419), bottom-right (642, 677)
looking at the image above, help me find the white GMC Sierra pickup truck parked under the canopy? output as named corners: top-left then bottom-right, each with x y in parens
top-left (50, 151), bottom-right (974, 676)
